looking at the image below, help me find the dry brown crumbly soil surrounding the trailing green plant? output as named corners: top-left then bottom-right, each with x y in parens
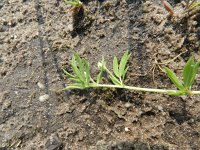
top-left (0, 0), bottom-right (200, 150)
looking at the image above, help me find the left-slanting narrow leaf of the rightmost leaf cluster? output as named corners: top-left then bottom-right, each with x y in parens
top-left (165, 67), bottom-right (184, 90)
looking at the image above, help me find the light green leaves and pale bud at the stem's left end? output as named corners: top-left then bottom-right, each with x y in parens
top-left (63, 51), bottom-right (130, 89)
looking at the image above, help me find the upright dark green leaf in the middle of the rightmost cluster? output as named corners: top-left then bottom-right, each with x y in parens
top-left (183, 57), bottom-right (194, 89)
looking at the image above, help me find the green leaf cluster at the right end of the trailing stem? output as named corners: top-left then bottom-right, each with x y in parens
top-left (165, 57), bottom-right (200, 95)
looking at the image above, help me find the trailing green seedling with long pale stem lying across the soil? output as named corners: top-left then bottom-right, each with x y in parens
top-left (63, 51), bottom-right (200, 96)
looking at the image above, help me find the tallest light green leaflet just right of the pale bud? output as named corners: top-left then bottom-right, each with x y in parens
top-left (119, 51), bottom-right (131, 77)
